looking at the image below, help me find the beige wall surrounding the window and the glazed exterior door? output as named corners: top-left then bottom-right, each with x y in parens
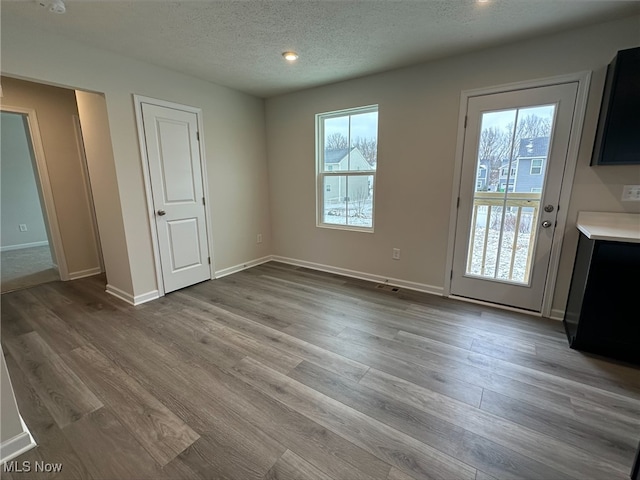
top-left (266, 17), bottom-right (640, 312)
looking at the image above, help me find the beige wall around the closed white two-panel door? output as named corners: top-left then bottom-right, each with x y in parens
top-left (2, 24), bottom-right (271, 296)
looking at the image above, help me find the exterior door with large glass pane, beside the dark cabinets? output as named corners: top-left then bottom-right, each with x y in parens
top-left (451, 82), bottom-right (578, 311)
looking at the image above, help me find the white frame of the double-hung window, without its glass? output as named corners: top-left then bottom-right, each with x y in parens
top-left (316, 105), bottom-right (379, 233)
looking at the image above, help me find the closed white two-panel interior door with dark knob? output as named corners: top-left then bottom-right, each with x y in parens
top-left (141, 103), bottom-right (211, 293)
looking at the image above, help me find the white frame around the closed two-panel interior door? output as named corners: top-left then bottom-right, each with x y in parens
top-left (133, 94), bottom-right (215, 297)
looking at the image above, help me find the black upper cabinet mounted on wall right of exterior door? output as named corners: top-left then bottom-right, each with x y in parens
top-left (591, 47), bottom-right (640, 165)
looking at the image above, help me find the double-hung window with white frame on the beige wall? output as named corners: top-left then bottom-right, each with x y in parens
top-left (316, 105), bottom-right (378, 232)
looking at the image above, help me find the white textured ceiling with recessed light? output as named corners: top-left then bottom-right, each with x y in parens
top-left (2, 0), bottom-right (640, 97)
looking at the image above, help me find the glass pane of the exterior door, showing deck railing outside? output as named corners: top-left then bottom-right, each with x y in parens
top-left (466, 105), bottom-right (556, 284)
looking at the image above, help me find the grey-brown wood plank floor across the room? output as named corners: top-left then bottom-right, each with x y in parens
top-left (2, 262), bottom-right (640, 480)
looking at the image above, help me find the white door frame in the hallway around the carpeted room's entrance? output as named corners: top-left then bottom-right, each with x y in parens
top-left (0, 105), bottom-right (69, 281)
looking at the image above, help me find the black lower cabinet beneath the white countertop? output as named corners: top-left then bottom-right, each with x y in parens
top-left (564, 234), bottom-right (640, 364)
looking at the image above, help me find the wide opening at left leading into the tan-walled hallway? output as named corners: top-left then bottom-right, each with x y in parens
top-left (0, 76), bottom-right (103, 293)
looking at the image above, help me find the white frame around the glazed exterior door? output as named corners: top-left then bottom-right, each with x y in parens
top-left (444, 71), bottom-right (591, 317)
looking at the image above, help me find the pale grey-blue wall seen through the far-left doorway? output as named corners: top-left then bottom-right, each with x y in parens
top-left (0, 112), bottom-right (48, 249)
